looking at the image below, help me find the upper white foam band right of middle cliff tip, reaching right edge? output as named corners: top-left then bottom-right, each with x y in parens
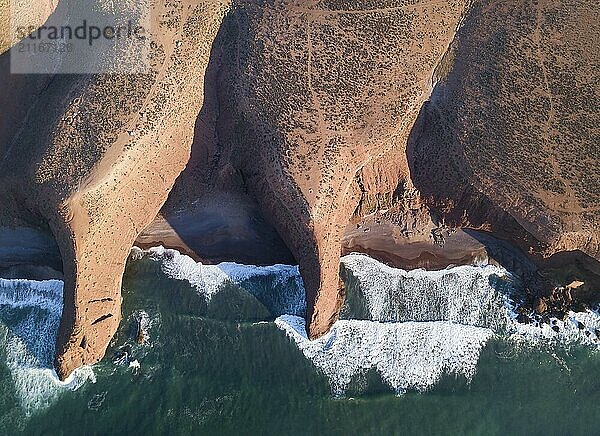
top-left (342, 254), bottom-right (600, 347)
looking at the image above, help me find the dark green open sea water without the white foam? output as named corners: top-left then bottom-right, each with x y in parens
top-left (0, 252), bottom-right (600, 435)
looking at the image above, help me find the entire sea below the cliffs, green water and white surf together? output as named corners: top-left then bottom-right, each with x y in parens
top-left (0, 248), bottom-right (600, 435)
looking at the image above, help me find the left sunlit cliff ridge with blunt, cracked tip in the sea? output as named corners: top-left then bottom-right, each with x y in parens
top-left (0, 1), bottom-right (228, 378)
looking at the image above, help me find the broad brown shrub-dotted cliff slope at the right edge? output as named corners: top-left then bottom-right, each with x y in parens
top-left (407, 0), bottom-right (600, 259)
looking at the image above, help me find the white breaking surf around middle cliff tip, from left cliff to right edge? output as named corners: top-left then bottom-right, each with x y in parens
top-left (127, 247), bottom-right (600, 395)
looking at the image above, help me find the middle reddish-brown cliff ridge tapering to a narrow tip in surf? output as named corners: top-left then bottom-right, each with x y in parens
top-left (166, 0), bottom-right (464, 337)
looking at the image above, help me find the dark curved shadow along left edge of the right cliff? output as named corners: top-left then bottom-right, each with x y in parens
top-left (406, 84), bottom-right (537, 281)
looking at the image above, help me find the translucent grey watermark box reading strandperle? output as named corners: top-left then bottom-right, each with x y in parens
top-left (9, 0), bottom-right (151, 74)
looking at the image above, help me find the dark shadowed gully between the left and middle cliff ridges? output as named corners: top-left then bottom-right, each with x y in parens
top-left (155, 1), bottom-right (332, 338)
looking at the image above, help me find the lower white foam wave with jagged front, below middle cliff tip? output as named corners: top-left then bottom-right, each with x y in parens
top-left (275, 315), bottom-right (493, 394)
